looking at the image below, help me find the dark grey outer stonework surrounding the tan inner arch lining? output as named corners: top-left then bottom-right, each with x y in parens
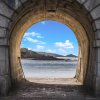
top-left (0, 0), bottom-right (100, 94)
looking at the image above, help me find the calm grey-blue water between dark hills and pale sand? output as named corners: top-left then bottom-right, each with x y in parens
top-left (21, 59), bottom-right (77, 78)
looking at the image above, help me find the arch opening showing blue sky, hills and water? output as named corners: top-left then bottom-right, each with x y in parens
top-left (21, 20), bottom-right (78, 84)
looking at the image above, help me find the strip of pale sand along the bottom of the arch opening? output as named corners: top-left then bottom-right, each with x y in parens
top-left (26, 77), bottom-right (82, 85)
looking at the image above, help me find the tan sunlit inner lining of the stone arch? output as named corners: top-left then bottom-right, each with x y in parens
top-left (10, 12), bottom-right (89, 83)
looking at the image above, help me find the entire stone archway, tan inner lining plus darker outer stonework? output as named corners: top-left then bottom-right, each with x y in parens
top-left (0, 0), bottom-right (100, 94)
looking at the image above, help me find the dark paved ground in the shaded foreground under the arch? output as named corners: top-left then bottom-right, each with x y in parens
top-left (0, 81), bottom-right (100, 100)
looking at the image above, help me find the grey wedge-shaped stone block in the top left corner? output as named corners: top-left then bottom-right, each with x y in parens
top-left (0, 1), bottom-right (13, 18)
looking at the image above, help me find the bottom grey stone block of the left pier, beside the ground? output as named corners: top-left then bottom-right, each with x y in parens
top-left (0, 75), bottom-right (11, 95)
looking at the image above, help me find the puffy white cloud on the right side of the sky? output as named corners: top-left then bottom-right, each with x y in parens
top-left (55, 40), bottom-right (74, 49)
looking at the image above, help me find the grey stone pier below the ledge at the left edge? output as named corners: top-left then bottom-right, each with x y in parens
top-left (0, 46), bottom-right (10, 95)
